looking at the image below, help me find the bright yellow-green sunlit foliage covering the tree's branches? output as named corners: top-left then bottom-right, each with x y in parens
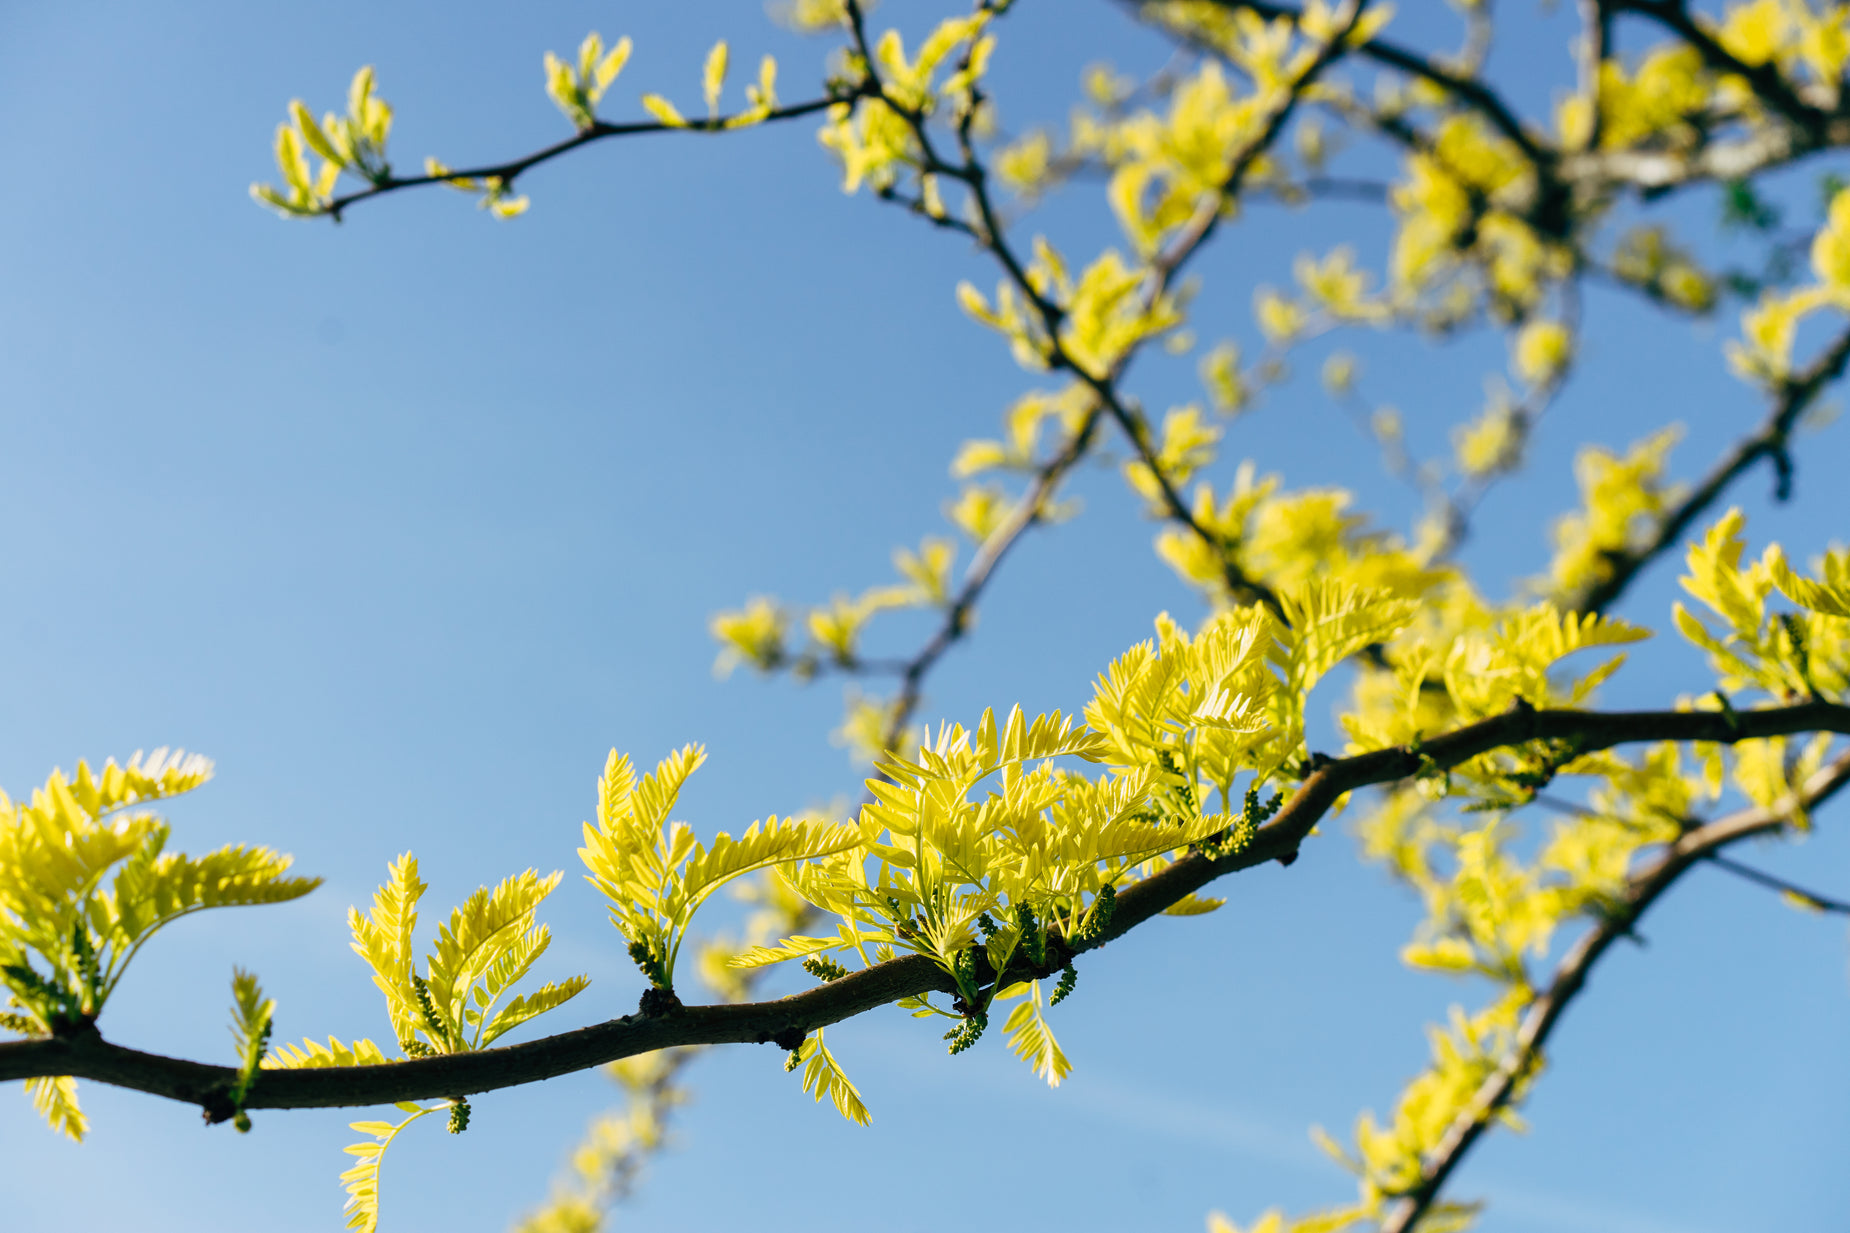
top-left (0, 0), bottom-right (1850, 1233)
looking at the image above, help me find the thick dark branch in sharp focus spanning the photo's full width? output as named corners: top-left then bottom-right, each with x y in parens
top-left (0, 702), bottom-right (1850, 1120)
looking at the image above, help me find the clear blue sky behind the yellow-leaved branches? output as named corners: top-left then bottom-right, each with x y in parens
top-left (0, 0), bottom-right (1850, 1233)
